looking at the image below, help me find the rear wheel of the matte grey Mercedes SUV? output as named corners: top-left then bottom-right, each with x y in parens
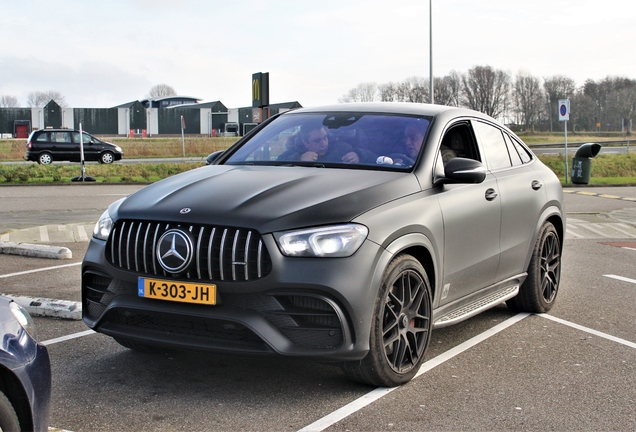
top-left (506, 222), bottom-right (561, 313)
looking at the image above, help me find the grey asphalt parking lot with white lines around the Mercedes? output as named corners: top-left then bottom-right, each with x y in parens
top-left (0, 185), bottom-right (636, 431)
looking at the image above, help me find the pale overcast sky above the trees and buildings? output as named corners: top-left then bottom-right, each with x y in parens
top-left (0, 0), bottom-right (636, 108)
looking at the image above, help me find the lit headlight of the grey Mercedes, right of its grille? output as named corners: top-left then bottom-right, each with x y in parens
top-left (275, 224), bottom-right (369, 258)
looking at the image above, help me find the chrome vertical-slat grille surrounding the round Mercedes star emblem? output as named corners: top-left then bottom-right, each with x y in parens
top-left (106, 220), bottom-right (272, 281)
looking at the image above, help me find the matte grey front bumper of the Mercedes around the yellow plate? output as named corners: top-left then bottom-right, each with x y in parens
top-left (82, 236), bottom-right (388, 360)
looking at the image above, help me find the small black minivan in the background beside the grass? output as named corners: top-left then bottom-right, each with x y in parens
top-left (26, 129), bottom-right (124, 165)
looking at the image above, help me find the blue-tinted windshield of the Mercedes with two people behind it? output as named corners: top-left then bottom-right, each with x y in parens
top-left (225, 112), bottom-right (430, 169)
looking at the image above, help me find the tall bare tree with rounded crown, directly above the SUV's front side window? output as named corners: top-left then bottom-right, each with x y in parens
top-left (462, 66), bottom-right (510, 118)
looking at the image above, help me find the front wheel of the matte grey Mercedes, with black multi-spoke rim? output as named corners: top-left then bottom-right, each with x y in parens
top-left (343, 251), bottom-right (432, 387)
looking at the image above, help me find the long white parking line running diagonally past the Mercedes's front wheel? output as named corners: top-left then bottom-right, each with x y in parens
top-left (298, 313), bottom-right (530, 432)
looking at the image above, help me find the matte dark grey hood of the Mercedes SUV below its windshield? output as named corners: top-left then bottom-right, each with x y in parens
top-left (111, 165), bottom-right (420, 234)
